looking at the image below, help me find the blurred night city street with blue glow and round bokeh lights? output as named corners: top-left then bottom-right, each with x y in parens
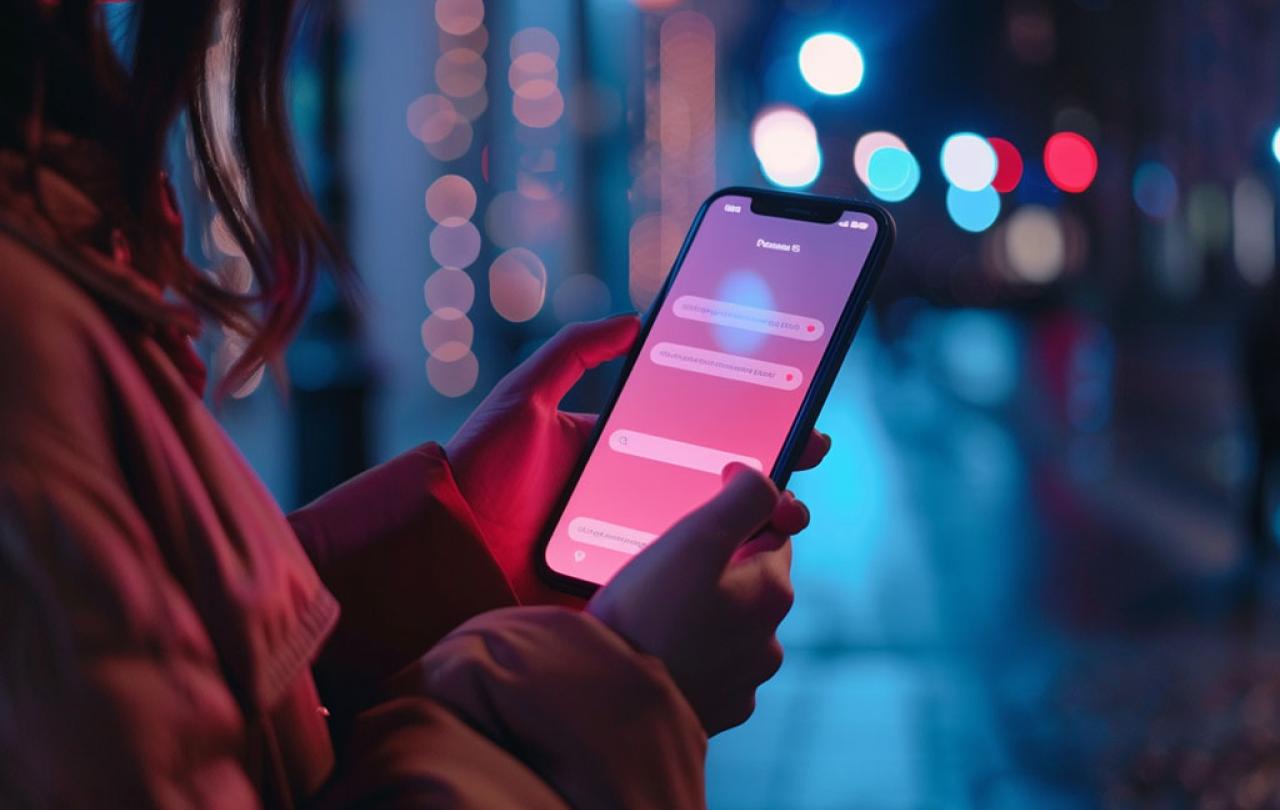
top-left (188, 0), bottom-right (1280, 810)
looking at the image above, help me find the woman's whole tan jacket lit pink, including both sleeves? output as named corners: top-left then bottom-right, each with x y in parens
top-left (0, 155), bottom-right (707, 810)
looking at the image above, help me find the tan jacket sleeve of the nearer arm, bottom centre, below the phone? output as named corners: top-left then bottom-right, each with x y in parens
top-left (314, 608), bottom-right (707, 810)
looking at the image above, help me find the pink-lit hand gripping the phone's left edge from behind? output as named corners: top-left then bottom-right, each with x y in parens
top-left (445, 315), bottom-right (831, 604)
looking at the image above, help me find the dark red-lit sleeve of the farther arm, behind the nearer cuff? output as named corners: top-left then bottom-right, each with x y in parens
top-left (289, 444), bottom-right (516, 713)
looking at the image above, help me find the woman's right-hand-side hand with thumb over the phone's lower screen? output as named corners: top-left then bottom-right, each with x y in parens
top-left (586, 465), bottom-right (809, 735)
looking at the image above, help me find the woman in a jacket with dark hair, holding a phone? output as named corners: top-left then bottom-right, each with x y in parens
top-left (0, 0), bottom-right (828, 809)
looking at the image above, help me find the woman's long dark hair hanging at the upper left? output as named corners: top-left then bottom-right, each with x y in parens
top-left (0, 0), bottom-right (351, 390)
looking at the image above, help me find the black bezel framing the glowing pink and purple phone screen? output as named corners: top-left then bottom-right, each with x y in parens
top-left (534, 186), bottom-right (897, 598)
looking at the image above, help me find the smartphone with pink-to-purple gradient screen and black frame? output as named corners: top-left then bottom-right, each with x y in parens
top-left (535, 188), bottom-right (893, 595)
